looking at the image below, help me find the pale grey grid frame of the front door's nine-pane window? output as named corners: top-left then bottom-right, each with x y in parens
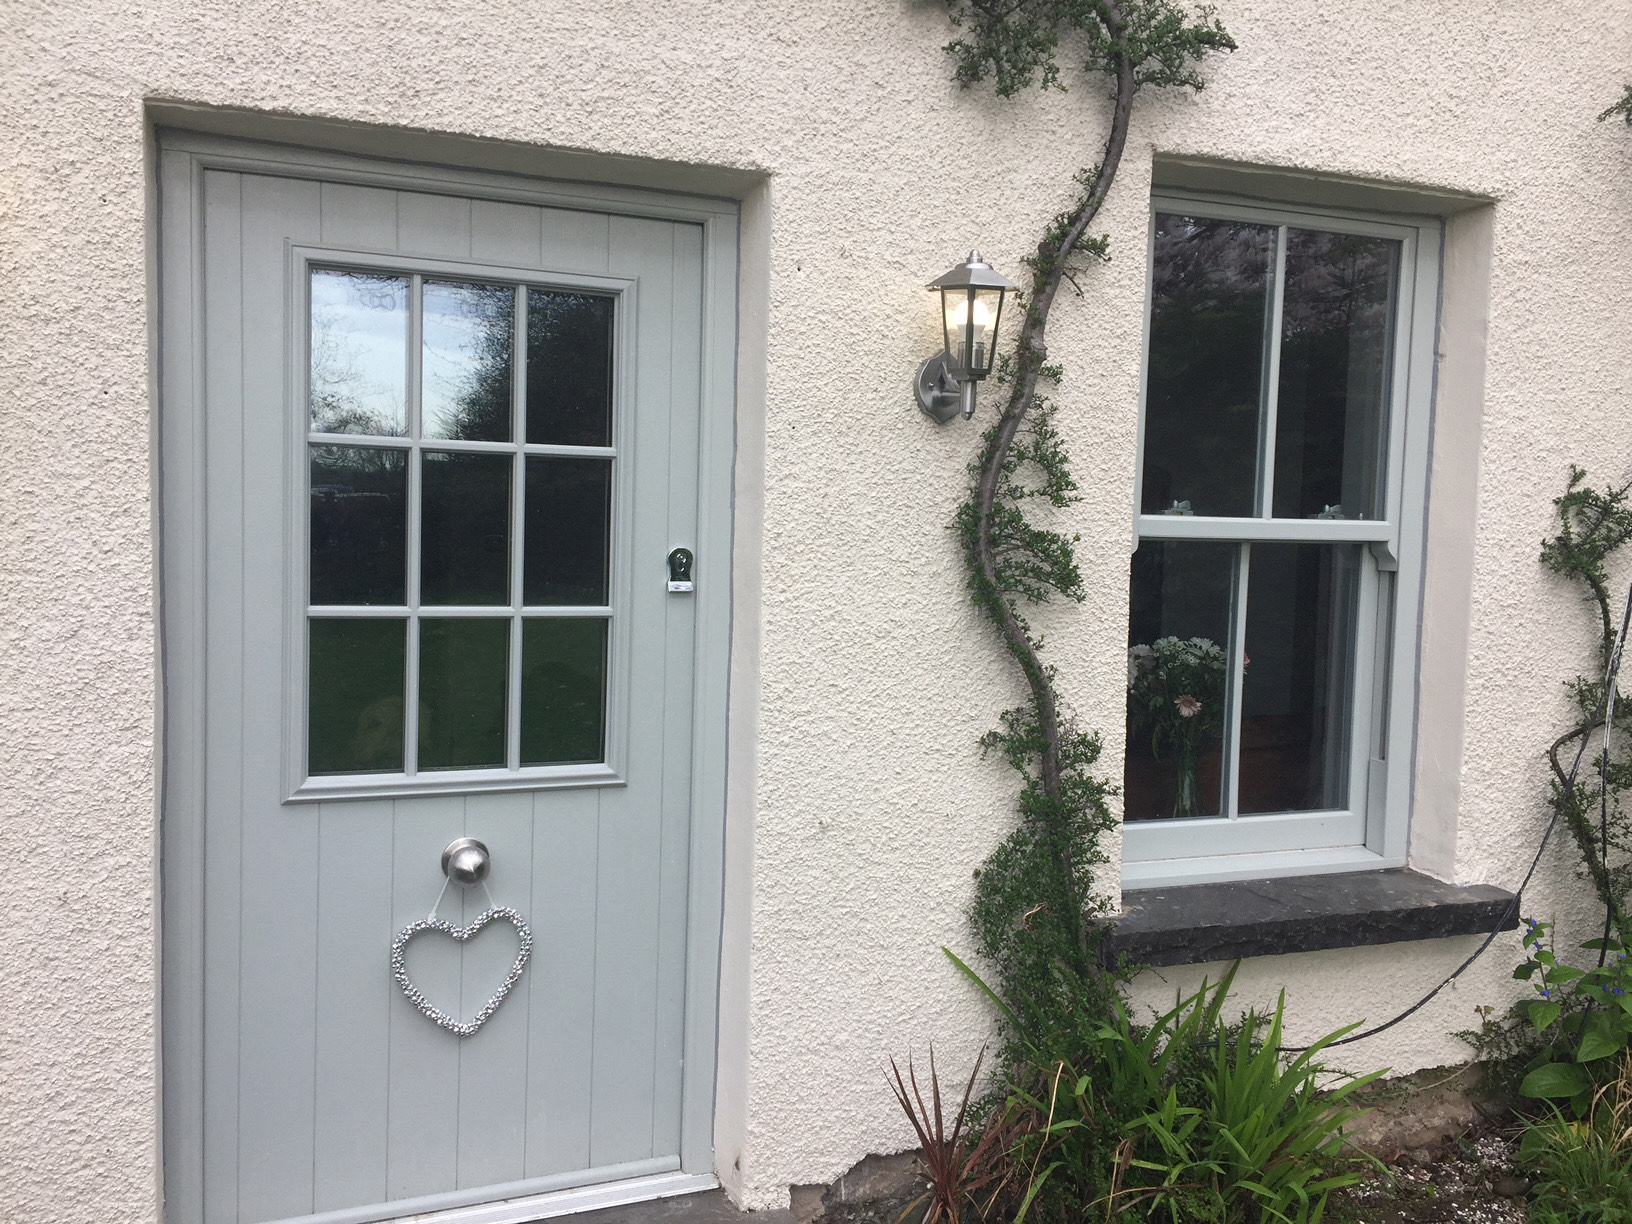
top-left (282, 245), bottom-right (638, 803)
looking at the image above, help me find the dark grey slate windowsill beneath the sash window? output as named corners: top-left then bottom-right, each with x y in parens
top-left (1100, 868), bottom-right (1519, 965)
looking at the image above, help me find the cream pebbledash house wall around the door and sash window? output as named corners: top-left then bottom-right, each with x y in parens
top-left (0, 0), bottom-right (1632, 1224)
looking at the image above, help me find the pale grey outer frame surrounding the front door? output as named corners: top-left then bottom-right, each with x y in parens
top-left (153, 129), bottom-right (739, 1224)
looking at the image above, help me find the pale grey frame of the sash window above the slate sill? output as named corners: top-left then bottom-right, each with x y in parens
top-left (1123, 189), bottom-right (1443, 888)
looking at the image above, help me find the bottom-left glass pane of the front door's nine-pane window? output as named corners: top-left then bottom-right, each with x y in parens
top-left (307, 617), bottom-right (408, 777)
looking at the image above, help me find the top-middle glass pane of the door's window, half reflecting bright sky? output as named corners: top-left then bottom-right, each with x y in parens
top-left (419, 281), bottom-right (516, 442)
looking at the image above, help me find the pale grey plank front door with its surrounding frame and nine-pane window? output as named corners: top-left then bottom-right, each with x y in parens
top-left (162, 140), bottom-right (730, 1224)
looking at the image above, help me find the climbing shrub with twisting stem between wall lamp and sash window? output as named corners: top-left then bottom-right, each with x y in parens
top-left (947, 0), bottom-right (1235, 1037)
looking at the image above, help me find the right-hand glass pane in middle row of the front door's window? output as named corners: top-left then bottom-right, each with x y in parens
top-left (522, 455), bottom-right (612, 604)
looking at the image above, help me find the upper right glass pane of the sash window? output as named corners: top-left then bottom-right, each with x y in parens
top-left (1273, 230), bottom-right (1400, 519)
